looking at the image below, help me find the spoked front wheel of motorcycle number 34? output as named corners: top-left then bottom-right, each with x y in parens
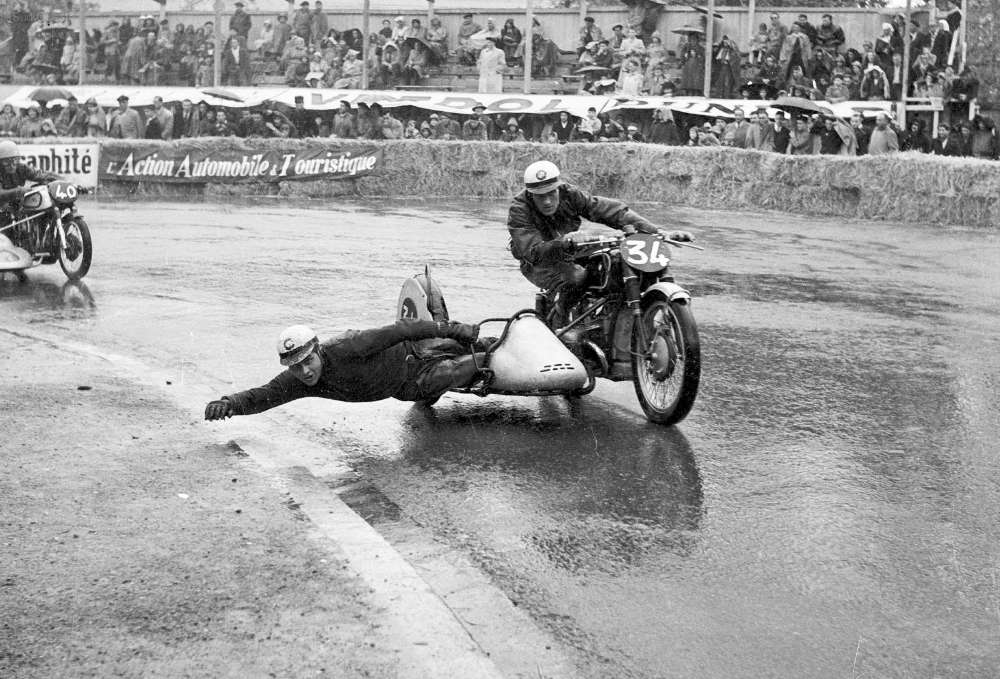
top-left (632, 294), bottom-right (701, 424)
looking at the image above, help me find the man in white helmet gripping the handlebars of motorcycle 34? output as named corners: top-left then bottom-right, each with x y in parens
top-left (507, 160), bottom-right (692, 327)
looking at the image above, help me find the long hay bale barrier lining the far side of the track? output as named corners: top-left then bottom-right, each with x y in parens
top-left (95, 138), bottom-right (1000, 227)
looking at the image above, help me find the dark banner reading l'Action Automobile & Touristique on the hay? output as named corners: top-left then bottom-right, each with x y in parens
top-left (100, 145), bottom-right (383, 183)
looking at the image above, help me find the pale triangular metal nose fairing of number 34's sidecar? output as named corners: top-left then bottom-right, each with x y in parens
top-left (488, 310), bottom-right (588, 395)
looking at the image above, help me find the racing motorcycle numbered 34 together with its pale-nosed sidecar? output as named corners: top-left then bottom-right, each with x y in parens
top-left (397, 233), bottom-right (702, 425)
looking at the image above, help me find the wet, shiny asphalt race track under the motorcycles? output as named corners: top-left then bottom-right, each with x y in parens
top-left (0, 202), bottom-right (1000, 679)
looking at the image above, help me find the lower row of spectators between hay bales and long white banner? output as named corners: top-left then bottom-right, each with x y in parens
top-left (0, 91), bottom-right (1000, 160)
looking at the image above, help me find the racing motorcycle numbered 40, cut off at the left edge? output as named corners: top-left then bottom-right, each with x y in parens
top-left (0, 180), bottom-right (94, 281)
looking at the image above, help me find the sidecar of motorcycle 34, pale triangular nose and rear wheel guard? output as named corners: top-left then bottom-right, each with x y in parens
top-left (396, 267), bottom-right (595, 396)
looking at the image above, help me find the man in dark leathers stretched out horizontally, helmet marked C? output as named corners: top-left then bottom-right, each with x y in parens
top-left (205, 320), bottom-right (486, 420)
